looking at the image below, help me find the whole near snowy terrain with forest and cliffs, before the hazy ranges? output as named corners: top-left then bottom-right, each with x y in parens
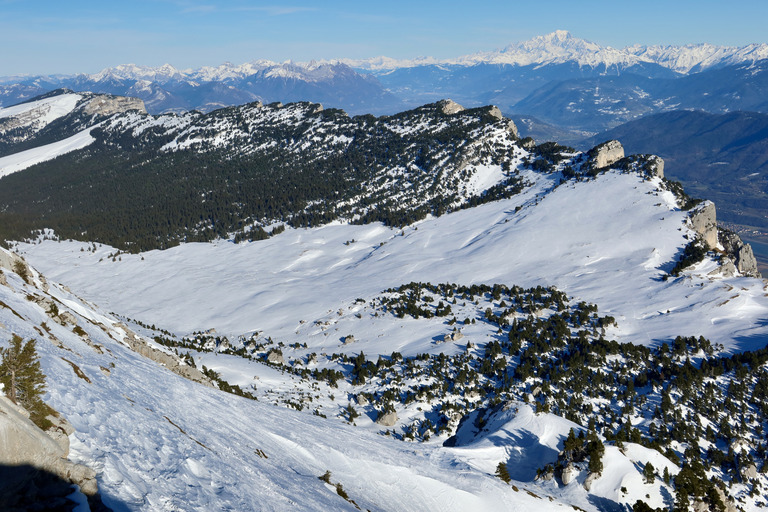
top-left (0, 46), bottom-right (768, 511)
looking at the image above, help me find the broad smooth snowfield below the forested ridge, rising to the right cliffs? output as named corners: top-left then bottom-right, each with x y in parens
top-left (22, 168), bottom-right (768, 354)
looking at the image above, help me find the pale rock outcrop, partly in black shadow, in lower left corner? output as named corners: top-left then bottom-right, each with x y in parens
top-left (0, 396), bottom-right (98, 505)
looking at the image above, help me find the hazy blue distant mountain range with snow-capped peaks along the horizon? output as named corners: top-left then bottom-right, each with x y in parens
top-left (0, 31), bottom-right (768, 135)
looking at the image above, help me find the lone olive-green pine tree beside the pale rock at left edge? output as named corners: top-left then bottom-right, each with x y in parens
top-left (0, 334), bottom-right (50, 427)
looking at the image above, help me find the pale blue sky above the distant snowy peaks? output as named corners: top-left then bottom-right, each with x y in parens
top-left (0, 0), bottom-right (768, 76)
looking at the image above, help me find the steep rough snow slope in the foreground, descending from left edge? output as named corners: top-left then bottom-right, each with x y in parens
top-left (0, 246), bottom-right (580, 511)
